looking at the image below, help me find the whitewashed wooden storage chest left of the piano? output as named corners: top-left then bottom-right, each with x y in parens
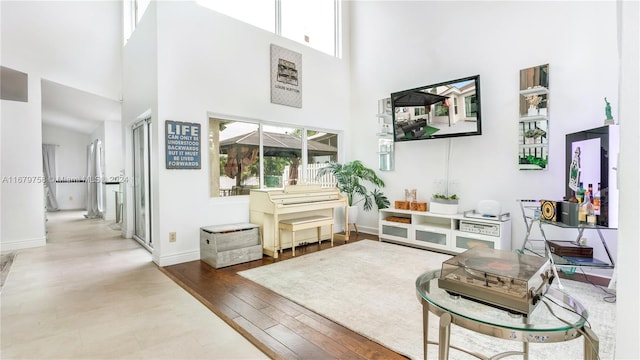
top-left (200, 223), bottom-right (262, 269)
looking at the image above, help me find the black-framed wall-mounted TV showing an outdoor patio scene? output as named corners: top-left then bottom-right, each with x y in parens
top-left (391, 75), bottom-right (482, 141)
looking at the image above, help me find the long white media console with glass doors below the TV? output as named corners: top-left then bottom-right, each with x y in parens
top-left (378, 209), bottom-right (511, 254)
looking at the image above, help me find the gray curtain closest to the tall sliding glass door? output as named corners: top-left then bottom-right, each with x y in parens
top-left (85, 139), bottom-right (104, 219)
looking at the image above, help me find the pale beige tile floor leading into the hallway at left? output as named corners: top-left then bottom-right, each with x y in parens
top-left (0, 211), bottom-right (267, 359)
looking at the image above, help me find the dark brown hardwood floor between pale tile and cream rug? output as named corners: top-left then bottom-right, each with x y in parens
top-left (162, 233), bottom-right (406, 359)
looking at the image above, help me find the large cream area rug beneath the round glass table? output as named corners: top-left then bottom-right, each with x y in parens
top-left (238, 240), bottom-right (615, 359)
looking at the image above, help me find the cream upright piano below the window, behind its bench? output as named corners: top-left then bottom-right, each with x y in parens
top-left (249, 185), bottom-right (349, 258)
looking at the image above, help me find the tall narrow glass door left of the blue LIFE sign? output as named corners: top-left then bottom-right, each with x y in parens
top-left (132, 118), bottom-right (153, 250)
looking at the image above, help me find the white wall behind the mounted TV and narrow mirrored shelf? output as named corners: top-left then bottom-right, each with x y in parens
top-left (351, 1), bottom-right (619, 274)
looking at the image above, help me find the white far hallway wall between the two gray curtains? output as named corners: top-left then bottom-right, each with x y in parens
top-left (42, 125), bottom-right (91, 210)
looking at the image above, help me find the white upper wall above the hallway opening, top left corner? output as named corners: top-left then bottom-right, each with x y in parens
top-left (2, 1), bottom-right (122, 99)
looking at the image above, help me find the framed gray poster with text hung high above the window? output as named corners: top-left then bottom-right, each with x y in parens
top-left (271, 44), bottom-right (302, 108)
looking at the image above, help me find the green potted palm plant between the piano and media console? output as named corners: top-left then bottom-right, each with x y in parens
top-left (317, 160), bottom-right (390, 224)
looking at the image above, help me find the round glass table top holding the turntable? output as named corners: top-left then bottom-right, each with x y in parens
top-left (416, 270), bottom-right (588, 332)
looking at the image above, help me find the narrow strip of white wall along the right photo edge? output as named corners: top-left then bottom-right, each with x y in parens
top-left (616, 1), bottom-right (640, 359)
